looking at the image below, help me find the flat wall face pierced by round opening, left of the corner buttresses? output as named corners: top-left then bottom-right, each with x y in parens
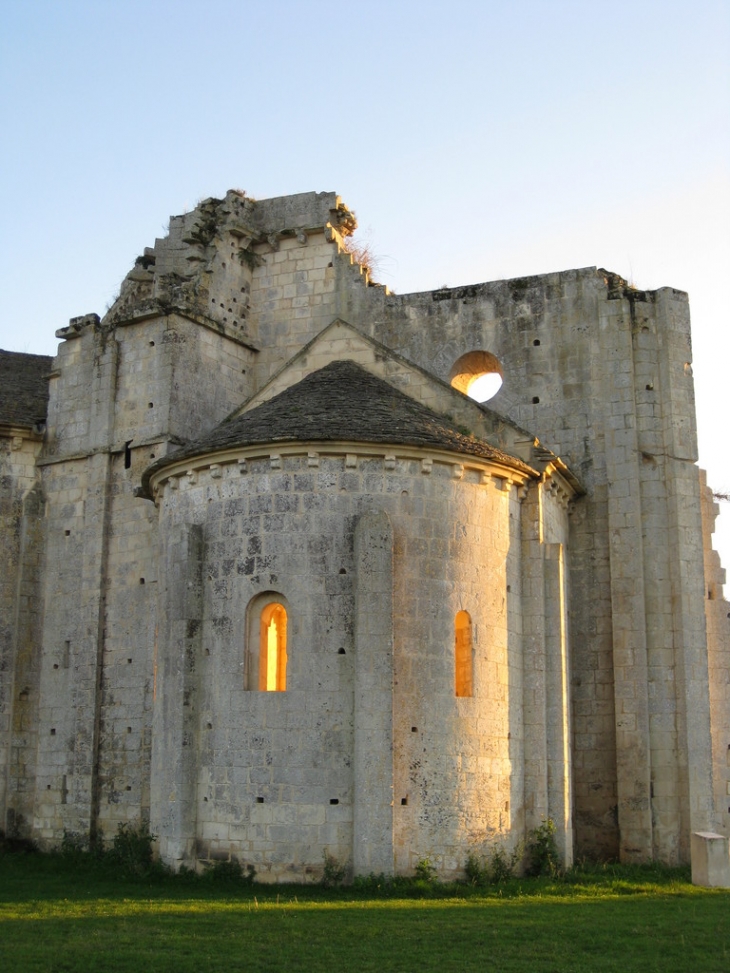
top-left (336, 269), bottom-right (618, 855)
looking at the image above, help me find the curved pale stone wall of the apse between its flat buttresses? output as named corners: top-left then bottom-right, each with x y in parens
top-left (152, 446), bottom-right (523, 880)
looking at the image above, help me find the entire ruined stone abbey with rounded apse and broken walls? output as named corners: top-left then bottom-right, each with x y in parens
top-left (0, 191), bottom-right (730, 881)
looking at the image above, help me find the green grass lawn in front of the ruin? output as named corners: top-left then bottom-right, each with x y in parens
top-left (0, 852), bottom-right (730, 973)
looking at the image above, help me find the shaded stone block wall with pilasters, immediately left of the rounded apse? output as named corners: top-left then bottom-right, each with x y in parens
top-left (34, 315), bottom-right (251, 842)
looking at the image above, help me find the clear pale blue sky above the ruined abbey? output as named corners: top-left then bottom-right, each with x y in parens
top-left (0, 0), bottom-right (730, 567)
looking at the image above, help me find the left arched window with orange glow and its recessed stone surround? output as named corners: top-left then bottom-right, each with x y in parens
top-left (244, 591), bottom-right (289, 692)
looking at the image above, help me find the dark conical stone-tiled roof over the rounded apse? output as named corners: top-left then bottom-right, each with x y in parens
top-left (143, 361), bottom-right (531, 492)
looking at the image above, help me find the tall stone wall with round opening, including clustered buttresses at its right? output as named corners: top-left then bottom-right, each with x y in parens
top-left (341, 268), bottom-right (714, 860)
